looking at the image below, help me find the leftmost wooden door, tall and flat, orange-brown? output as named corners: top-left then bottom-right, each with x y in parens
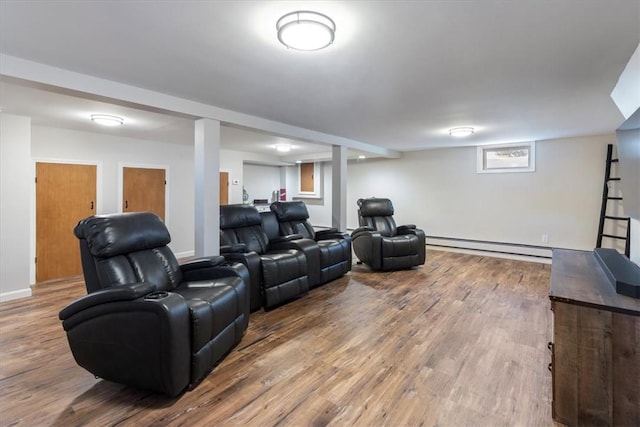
top-left (36, 162), bottom-right (97, 282)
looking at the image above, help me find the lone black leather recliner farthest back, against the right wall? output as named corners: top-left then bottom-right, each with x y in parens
top-left (351, 198), bottom-right (426, 271)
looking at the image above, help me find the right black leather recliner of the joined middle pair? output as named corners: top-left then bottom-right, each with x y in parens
top-left (270, 201), bottom-right (351, 285)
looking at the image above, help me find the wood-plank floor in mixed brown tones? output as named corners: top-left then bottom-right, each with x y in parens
top-left (0, 250), bottom-right (554, 426)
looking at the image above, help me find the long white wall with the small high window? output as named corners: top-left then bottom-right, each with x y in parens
top-left (305, 135), bottom-right (615, 250)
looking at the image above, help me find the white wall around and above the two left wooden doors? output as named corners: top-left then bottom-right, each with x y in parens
top-left (31, 126), bottom-right (194, 256)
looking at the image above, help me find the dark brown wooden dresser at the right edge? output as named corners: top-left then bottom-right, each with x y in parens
top-left (549, 249), bottom-right (640, 426)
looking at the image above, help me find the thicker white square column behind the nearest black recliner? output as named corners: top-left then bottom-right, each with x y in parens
top-left (194, 119), bottom-right (220, 257)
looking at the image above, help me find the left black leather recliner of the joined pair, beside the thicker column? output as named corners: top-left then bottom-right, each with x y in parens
top-left (220, 205), bottom-right (309, 311)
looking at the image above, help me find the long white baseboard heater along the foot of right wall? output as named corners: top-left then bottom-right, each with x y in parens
top-left (425, 236), bottom-right (552, 260)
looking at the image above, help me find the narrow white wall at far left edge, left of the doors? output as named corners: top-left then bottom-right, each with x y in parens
top-left (0, 113), bottom-right (35, 301)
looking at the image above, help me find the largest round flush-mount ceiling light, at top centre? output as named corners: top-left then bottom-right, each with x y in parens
top-left (276, 10), bottom-right (336, 51)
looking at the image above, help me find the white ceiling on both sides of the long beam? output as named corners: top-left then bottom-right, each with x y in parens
top-left (0, 0), bottom-right (640, 156)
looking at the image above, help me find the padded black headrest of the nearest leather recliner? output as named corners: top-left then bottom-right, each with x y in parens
top-left (73, 212), bottom-right (171, 258)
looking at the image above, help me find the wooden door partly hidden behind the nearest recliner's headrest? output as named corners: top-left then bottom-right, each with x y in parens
top-left (122, 168), bottom-right (166, 221)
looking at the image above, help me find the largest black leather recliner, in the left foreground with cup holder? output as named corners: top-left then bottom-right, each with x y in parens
top-left (59, 212), bottom-right (249, 396)
